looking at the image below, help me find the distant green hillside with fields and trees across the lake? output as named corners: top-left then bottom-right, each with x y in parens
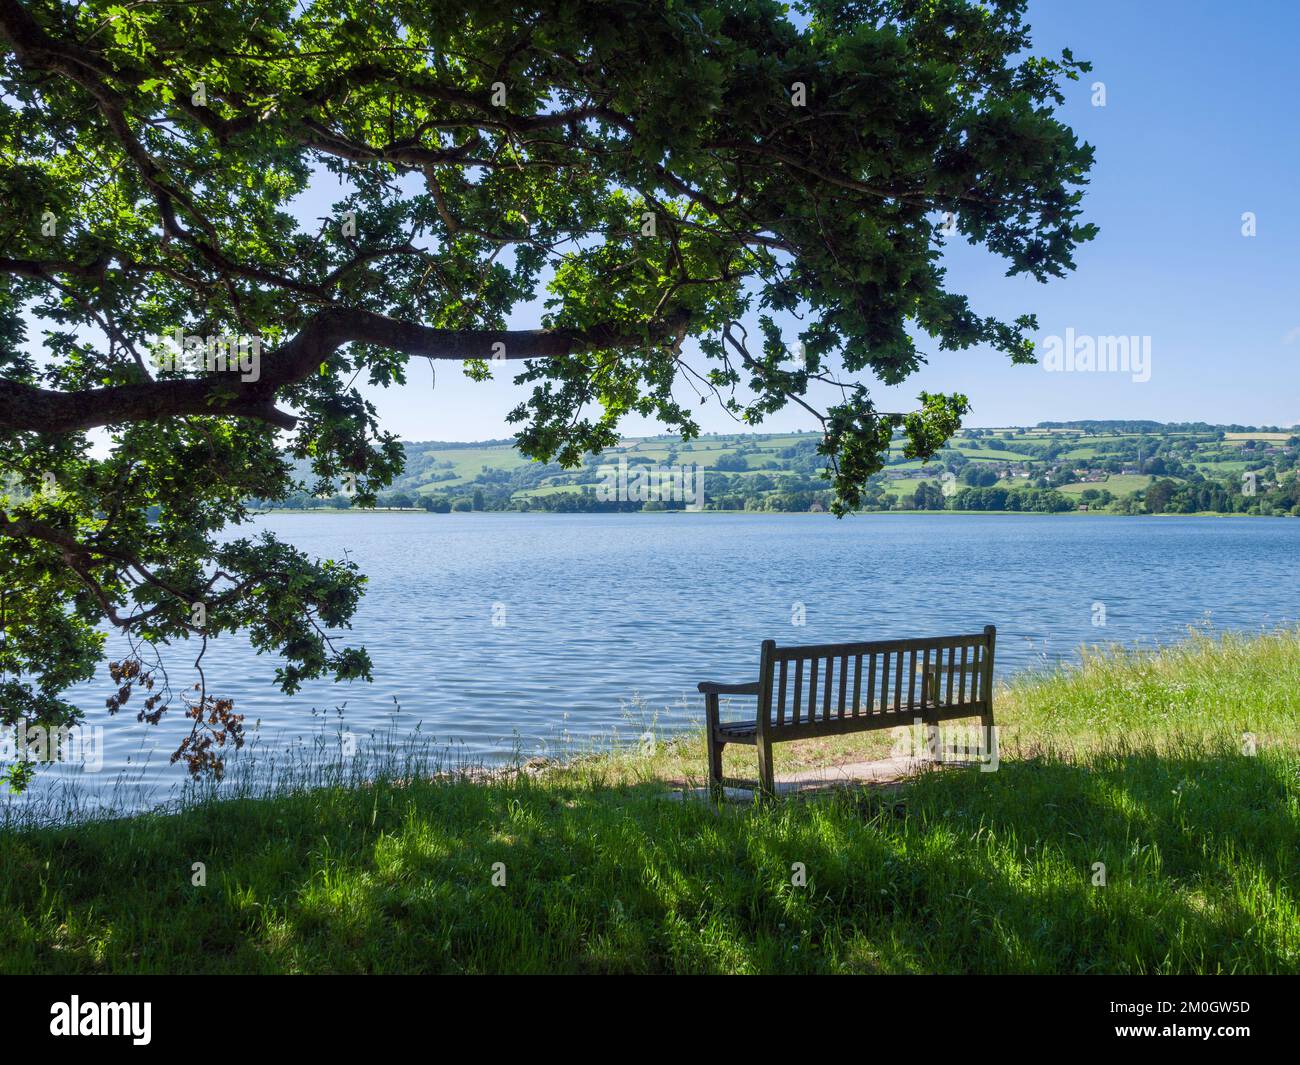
top-left (263, 420), bottom-right (1300, 514)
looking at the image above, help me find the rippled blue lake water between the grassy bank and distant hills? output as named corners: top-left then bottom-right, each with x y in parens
top-left (10, 514), bottom-right (1300, 805)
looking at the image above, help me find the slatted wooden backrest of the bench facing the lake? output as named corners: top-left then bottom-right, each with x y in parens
top-left (758, 625), bottom-right (997, 735)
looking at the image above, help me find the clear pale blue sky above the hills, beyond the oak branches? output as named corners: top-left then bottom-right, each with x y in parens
top-left (351, 0), bottom-right (1300, 440)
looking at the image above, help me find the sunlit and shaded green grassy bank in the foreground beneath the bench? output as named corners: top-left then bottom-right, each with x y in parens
top-left (0, 633), bottom-right (1300, 973)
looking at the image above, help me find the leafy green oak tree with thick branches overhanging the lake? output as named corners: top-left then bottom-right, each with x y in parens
top-left (0, 0), bottom-right (1093, 783)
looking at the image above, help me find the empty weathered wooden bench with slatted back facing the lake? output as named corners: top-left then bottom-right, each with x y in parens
top-left (699, 625), bottom-right (997, 797)
